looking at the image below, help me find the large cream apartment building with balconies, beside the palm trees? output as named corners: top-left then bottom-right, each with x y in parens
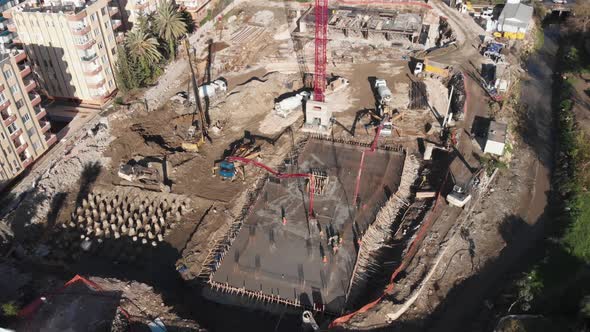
top-left (3, 0), bottom-right (123, 105)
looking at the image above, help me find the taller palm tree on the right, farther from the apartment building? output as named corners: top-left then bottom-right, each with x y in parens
top-left (154, 1), bottom-right (187, 57)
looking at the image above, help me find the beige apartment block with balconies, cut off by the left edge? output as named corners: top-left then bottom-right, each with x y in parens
top-left (0, 50), bottom-right (57, 189)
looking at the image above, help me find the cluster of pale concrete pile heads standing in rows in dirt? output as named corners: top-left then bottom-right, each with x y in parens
top-left (64, 192), bottom-right (190, 250)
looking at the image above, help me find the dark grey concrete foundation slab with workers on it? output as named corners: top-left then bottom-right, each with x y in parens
top-left (209, 139), bottom-right (405, 313)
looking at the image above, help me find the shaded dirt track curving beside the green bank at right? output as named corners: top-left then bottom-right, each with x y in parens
top-left (414, 27), bottom-right (558, 331)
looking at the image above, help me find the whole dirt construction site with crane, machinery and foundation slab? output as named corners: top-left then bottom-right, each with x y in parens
top-left (0, 0), bottom-right (528, 330)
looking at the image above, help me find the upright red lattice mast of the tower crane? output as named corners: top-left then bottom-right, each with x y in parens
top-left (313, 0), bottom-right (328, 102)
